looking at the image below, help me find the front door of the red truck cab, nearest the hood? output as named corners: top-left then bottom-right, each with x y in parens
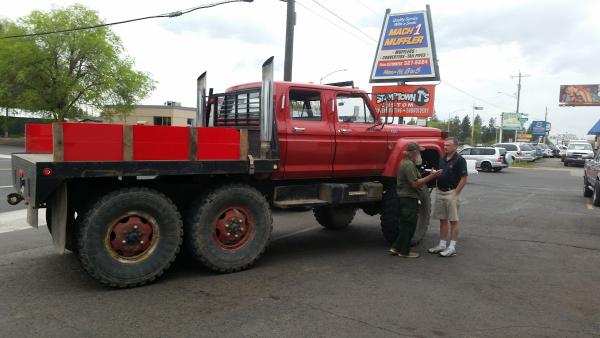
top-left (333, 93), bottom-right (388, 177)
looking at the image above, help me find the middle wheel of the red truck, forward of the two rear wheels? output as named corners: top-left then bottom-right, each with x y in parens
top-left (185, 184), bottom-right (273, 272)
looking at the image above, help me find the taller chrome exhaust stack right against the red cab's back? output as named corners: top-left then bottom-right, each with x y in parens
top-left (260, 56), bottom-right (275, 158)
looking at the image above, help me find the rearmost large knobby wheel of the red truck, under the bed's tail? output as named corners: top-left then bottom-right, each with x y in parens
top-left (77, 187), bottom-right (183, 288)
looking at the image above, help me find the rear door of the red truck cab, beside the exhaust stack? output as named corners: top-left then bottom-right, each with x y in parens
top-left (283, 88), bottom-right (334, 179)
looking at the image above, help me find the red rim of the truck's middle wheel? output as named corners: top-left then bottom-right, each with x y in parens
top-left (212, 207), bottom-right (254, 250)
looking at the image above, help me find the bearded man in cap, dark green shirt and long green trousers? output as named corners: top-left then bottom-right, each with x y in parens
top-left (390, 142), bottom-right (442, 258)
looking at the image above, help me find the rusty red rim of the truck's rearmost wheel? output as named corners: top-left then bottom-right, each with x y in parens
top-left (105, 212), bottom-right (159, 263)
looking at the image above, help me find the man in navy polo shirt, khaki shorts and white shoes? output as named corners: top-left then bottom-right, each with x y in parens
top-left (428, 137), bottom-right (468, 257)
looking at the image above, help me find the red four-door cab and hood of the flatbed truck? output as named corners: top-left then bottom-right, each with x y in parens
top-left (221, 82), bottom-right (443, 179)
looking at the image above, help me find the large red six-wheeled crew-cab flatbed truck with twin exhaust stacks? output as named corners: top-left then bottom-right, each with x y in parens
top-left (8, 58), bottom-right (445, 287)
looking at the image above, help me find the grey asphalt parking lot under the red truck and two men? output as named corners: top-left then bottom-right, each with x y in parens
top-left (0, 152), bottom-right (600, 337)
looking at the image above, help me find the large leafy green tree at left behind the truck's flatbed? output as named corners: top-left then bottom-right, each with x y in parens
top-left (0, 5), bottom-right (155, 120)
